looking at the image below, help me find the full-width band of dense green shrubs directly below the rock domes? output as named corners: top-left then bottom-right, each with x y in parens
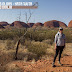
top-left (0, 28), bottom-right (72, 44)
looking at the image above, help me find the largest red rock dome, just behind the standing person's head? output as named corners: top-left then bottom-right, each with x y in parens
top-left (44, 20), bottom-right (67, 27)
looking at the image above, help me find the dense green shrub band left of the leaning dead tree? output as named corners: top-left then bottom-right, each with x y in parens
top-left (0, 29), bottom-right (25, 40)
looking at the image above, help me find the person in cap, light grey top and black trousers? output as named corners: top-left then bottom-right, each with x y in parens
top-left (52, 27), bottom-right (65, 67)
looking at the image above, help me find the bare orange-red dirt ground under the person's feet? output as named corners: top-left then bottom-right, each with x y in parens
top-left (13, 56), bottom-right (72, 72)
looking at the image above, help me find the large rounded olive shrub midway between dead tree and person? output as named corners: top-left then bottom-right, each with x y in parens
top-left (24, 41), bottom-right (48, 58)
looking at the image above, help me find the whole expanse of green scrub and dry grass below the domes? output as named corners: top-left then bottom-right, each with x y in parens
top-left (0, 28), bottom-right (72, 72)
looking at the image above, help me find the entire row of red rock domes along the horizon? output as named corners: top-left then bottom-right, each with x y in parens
top-left (0, 20), bottom-right (68, 29)
